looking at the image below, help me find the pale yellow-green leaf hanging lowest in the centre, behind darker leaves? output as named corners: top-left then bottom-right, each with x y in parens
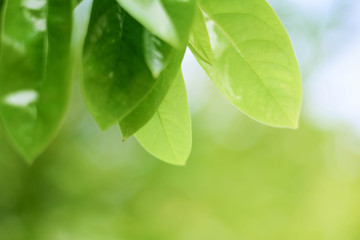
top-left (135, 71), bottom-right (192, 165)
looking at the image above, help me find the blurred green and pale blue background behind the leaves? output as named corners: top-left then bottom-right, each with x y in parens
top-left (0, 0), bottom-right (360, 240)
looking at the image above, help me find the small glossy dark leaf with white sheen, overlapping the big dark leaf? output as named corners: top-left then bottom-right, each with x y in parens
top-left (144, 30), bottom-right (174, 78)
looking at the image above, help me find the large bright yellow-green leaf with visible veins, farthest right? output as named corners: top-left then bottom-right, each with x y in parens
top-left (198, 0), bottom-right (302, 128)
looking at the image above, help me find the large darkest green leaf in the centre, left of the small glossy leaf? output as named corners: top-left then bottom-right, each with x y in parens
top-left (83, 0), bottom-right (157, 129)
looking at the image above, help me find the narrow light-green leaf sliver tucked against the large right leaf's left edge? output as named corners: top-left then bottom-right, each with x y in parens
top-left (188, 3), bottom-right (214, 65)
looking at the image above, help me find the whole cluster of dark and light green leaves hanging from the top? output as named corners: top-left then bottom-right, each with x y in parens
top-left (0, 0), bottom-right (301, 165)
